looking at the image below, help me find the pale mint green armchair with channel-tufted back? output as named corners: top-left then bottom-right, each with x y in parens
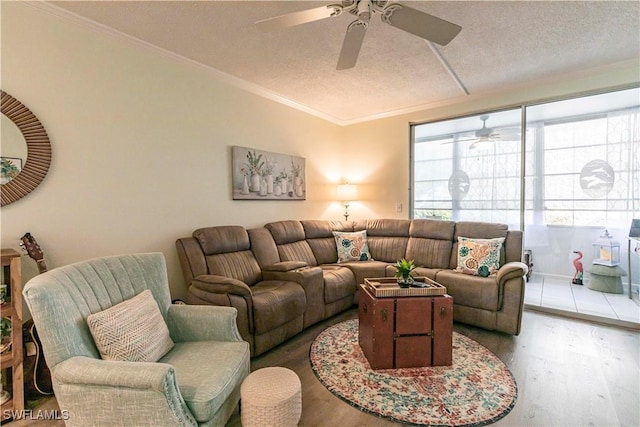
top-left (23, 253), bottom-right (249, 426)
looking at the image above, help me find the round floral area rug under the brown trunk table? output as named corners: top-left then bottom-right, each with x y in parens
top-left (309, 320), bottom-right (518, 426)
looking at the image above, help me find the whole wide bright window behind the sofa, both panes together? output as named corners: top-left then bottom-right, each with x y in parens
top-left (411, 89), bottom-right (640, 229)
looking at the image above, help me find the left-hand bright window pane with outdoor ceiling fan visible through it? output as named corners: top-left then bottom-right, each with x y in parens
top-left (412, 109), bottom-right (522, 228)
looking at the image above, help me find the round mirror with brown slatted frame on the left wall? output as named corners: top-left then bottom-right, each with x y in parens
top-left (0, 90), bottom-right (51, 206)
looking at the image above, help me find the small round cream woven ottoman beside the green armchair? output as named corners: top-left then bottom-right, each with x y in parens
top-left (240, 367), bottom-right (302, 427)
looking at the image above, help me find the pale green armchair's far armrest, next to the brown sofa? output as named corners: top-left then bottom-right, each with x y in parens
top-left (167, 304), bottom-right (242, 342)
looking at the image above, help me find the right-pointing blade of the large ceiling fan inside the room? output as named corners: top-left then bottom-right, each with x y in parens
top-left (382, 4), bottom-right (462, 46)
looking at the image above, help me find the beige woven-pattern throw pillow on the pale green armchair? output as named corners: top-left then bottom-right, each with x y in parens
top-left (87, 289), bottom-right (174, 362)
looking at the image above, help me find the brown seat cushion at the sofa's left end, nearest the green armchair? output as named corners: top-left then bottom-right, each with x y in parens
top-left (251, 280), bottom-right (307, 334)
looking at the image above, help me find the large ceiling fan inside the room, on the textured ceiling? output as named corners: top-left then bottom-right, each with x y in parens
top-left (256, 0), bottom-right (462, 70)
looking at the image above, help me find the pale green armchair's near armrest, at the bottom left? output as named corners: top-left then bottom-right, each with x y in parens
top-left (52, 356), bottom-right (197, 426)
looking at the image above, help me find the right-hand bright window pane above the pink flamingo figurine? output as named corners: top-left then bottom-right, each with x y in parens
top-left (526, 91), bottom-right (640, 227)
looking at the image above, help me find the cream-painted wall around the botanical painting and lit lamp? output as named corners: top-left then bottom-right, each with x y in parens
top-left (1, 2), bottom-right (638, 304)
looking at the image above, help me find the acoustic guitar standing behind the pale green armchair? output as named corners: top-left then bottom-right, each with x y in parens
top-left (20, 233), bottom-right (53, 399)
